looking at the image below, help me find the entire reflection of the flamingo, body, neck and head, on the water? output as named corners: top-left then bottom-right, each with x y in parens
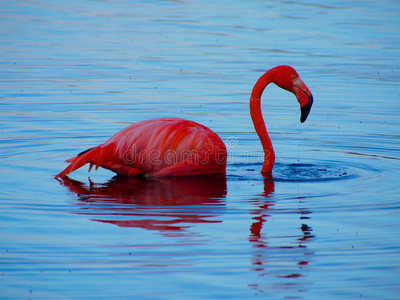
top-left (62, 176), bottom-right (314, 293)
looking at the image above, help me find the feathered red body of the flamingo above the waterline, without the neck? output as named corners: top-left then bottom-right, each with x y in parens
top-left (56, 118), bottom-right (227, 178)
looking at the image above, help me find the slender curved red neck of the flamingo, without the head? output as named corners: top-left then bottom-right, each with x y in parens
top-left (250, 71), bottom-right (275, 173)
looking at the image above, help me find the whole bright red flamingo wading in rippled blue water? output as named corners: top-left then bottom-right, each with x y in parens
top-left (55, 66), bottom-right (313, 179)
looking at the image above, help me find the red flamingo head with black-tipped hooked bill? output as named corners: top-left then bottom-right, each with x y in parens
top-left (271, 66), bottom-right (313, 123)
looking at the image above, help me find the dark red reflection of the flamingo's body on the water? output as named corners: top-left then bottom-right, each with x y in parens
top-left (62, 175), bottom-right (226, 235)
